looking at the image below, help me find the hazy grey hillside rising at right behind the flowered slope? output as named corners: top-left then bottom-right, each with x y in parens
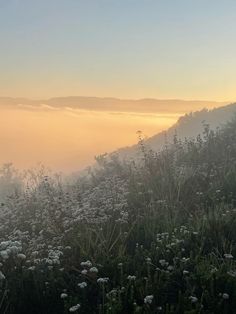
top-left (115, 103), bottom-right (236, 159)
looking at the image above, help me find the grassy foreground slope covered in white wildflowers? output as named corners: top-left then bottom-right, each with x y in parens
top-left (0, 120), bottom-right (236, 314)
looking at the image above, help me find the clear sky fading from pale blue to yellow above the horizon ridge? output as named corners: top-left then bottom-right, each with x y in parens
top-left (0, 0), bottom-right (236, 100)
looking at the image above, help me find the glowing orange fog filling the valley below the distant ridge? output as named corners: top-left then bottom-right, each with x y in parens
top-left (0, 106), bottom-right (179, 172)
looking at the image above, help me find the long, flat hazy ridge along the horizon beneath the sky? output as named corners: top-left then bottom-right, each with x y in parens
top-left (0, 96), bottom-right (226, 114)
